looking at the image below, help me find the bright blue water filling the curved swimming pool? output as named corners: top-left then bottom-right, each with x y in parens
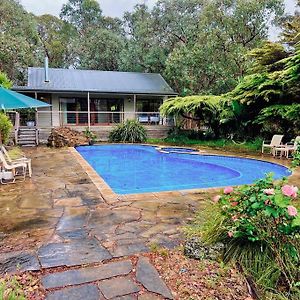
top-left (76, 145), bottom-right (291, 194)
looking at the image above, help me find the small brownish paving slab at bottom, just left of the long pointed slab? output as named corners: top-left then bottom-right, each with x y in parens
top-left (98, 277), bottom-right (140, 299)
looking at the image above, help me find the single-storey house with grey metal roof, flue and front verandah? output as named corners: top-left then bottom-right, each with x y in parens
top-left (13, 61), bottom-right (177, 140)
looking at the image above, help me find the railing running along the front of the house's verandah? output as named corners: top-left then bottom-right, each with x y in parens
top-left (36, 110), bottom-right (173, 128)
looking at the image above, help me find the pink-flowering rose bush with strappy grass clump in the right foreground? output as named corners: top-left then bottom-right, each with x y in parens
top-left (200, 175), bottom-right (300, 299)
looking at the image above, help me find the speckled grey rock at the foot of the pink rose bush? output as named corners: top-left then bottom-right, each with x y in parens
top-left (184, 238), bottom-right (224, 260)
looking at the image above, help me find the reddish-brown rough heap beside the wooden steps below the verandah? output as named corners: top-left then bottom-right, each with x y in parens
top-left (48, 127), bottom-right (89, 148)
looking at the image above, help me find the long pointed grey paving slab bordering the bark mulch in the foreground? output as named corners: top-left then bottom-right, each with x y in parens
top-left (136, 257), bottom-right (173, 299)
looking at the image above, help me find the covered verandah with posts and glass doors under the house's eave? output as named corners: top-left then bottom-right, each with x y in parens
top-left (15, 91), bottom-right (170, 129)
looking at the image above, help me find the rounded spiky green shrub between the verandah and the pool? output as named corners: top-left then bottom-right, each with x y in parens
top-left (109, 120), bottom-right (147, 143)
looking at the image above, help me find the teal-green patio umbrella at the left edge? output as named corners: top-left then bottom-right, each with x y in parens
top-left (0, 86), bottom-right (51, 110)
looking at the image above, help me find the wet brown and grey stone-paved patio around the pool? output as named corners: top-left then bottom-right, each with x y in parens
top-left (0, 147), bottom-right (300, 300)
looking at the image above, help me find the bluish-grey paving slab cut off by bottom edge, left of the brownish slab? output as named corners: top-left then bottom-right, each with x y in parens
top-left (46, 285), bottom-right (100, 300)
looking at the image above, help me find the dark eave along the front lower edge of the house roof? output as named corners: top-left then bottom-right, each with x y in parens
top-left (12, 86), bottom-right (178, 96)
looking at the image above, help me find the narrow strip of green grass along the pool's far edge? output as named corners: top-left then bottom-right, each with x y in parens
top-left (147, 138), bottom-right (262, 153)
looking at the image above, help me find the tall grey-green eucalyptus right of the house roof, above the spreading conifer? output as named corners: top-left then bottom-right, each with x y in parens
top-left (165, 0), bottom-right (283, 94)
